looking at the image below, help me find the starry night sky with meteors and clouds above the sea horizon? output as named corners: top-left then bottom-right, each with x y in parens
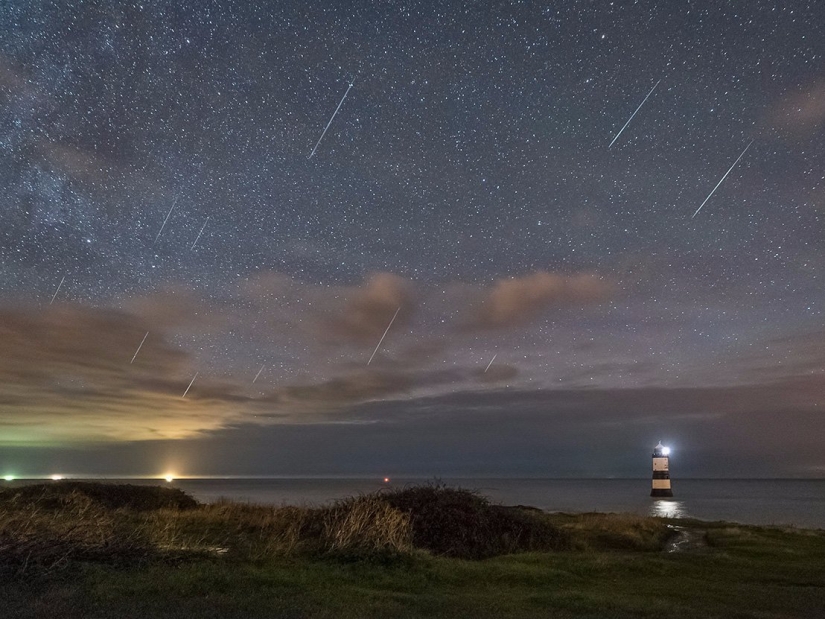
top-left (0, 0), bottom-right (825, 477)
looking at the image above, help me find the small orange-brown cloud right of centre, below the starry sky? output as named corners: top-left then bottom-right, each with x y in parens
top-left (465, 271), bottom-right (611, 329)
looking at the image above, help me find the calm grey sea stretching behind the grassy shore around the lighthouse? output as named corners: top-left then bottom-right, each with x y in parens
top-left (69, 478), bottom-right (825, 529)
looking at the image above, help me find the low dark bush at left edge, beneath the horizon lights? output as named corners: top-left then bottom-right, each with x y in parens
top-left (0, 481), bottom-right (198, 511)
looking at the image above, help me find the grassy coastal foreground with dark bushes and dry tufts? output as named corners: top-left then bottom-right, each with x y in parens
top-left (0, 482), bottom-right (825, 619)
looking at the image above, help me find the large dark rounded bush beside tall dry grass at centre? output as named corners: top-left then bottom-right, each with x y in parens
top-left (383, 484), bottom-right (569, 559)
